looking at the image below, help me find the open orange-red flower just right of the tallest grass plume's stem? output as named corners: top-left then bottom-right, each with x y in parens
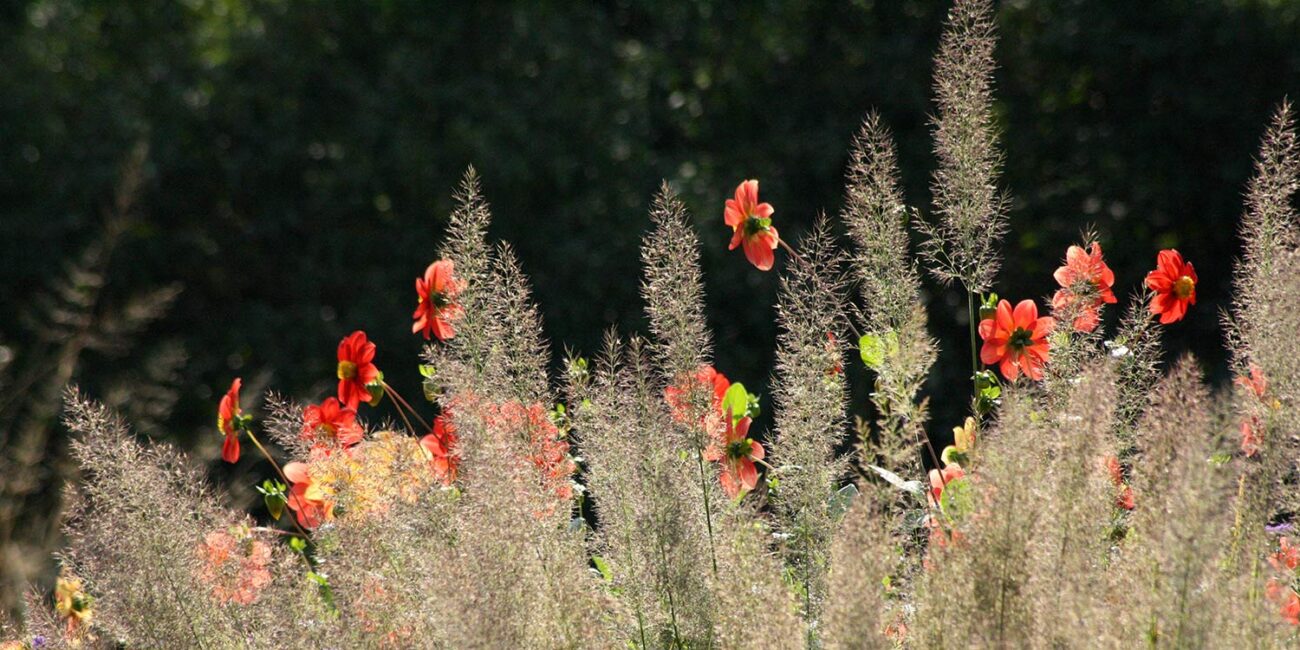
top-left (979, 300), bottom-right (1056, 381)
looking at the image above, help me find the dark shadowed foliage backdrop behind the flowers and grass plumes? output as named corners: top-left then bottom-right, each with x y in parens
top-left (0, 0), bottom-right (1300, 603)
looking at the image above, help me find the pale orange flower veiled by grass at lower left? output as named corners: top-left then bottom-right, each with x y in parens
top-left (198, 527), bottom-right (270, 605)
